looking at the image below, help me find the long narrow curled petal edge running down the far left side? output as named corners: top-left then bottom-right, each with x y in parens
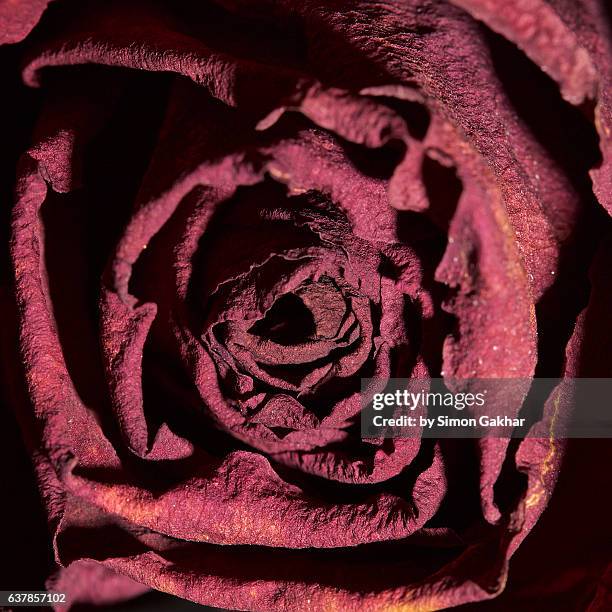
top-left (11, 89), bottom-right (126, 474)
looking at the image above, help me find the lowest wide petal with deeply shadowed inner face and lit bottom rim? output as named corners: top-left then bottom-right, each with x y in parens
top-left (50, 490), bottom-right (514, 610)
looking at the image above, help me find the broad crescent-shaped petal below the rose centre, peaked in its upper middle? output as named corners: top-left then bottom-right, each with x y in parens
top-left (62, 452), bottom-right (444, 548)
